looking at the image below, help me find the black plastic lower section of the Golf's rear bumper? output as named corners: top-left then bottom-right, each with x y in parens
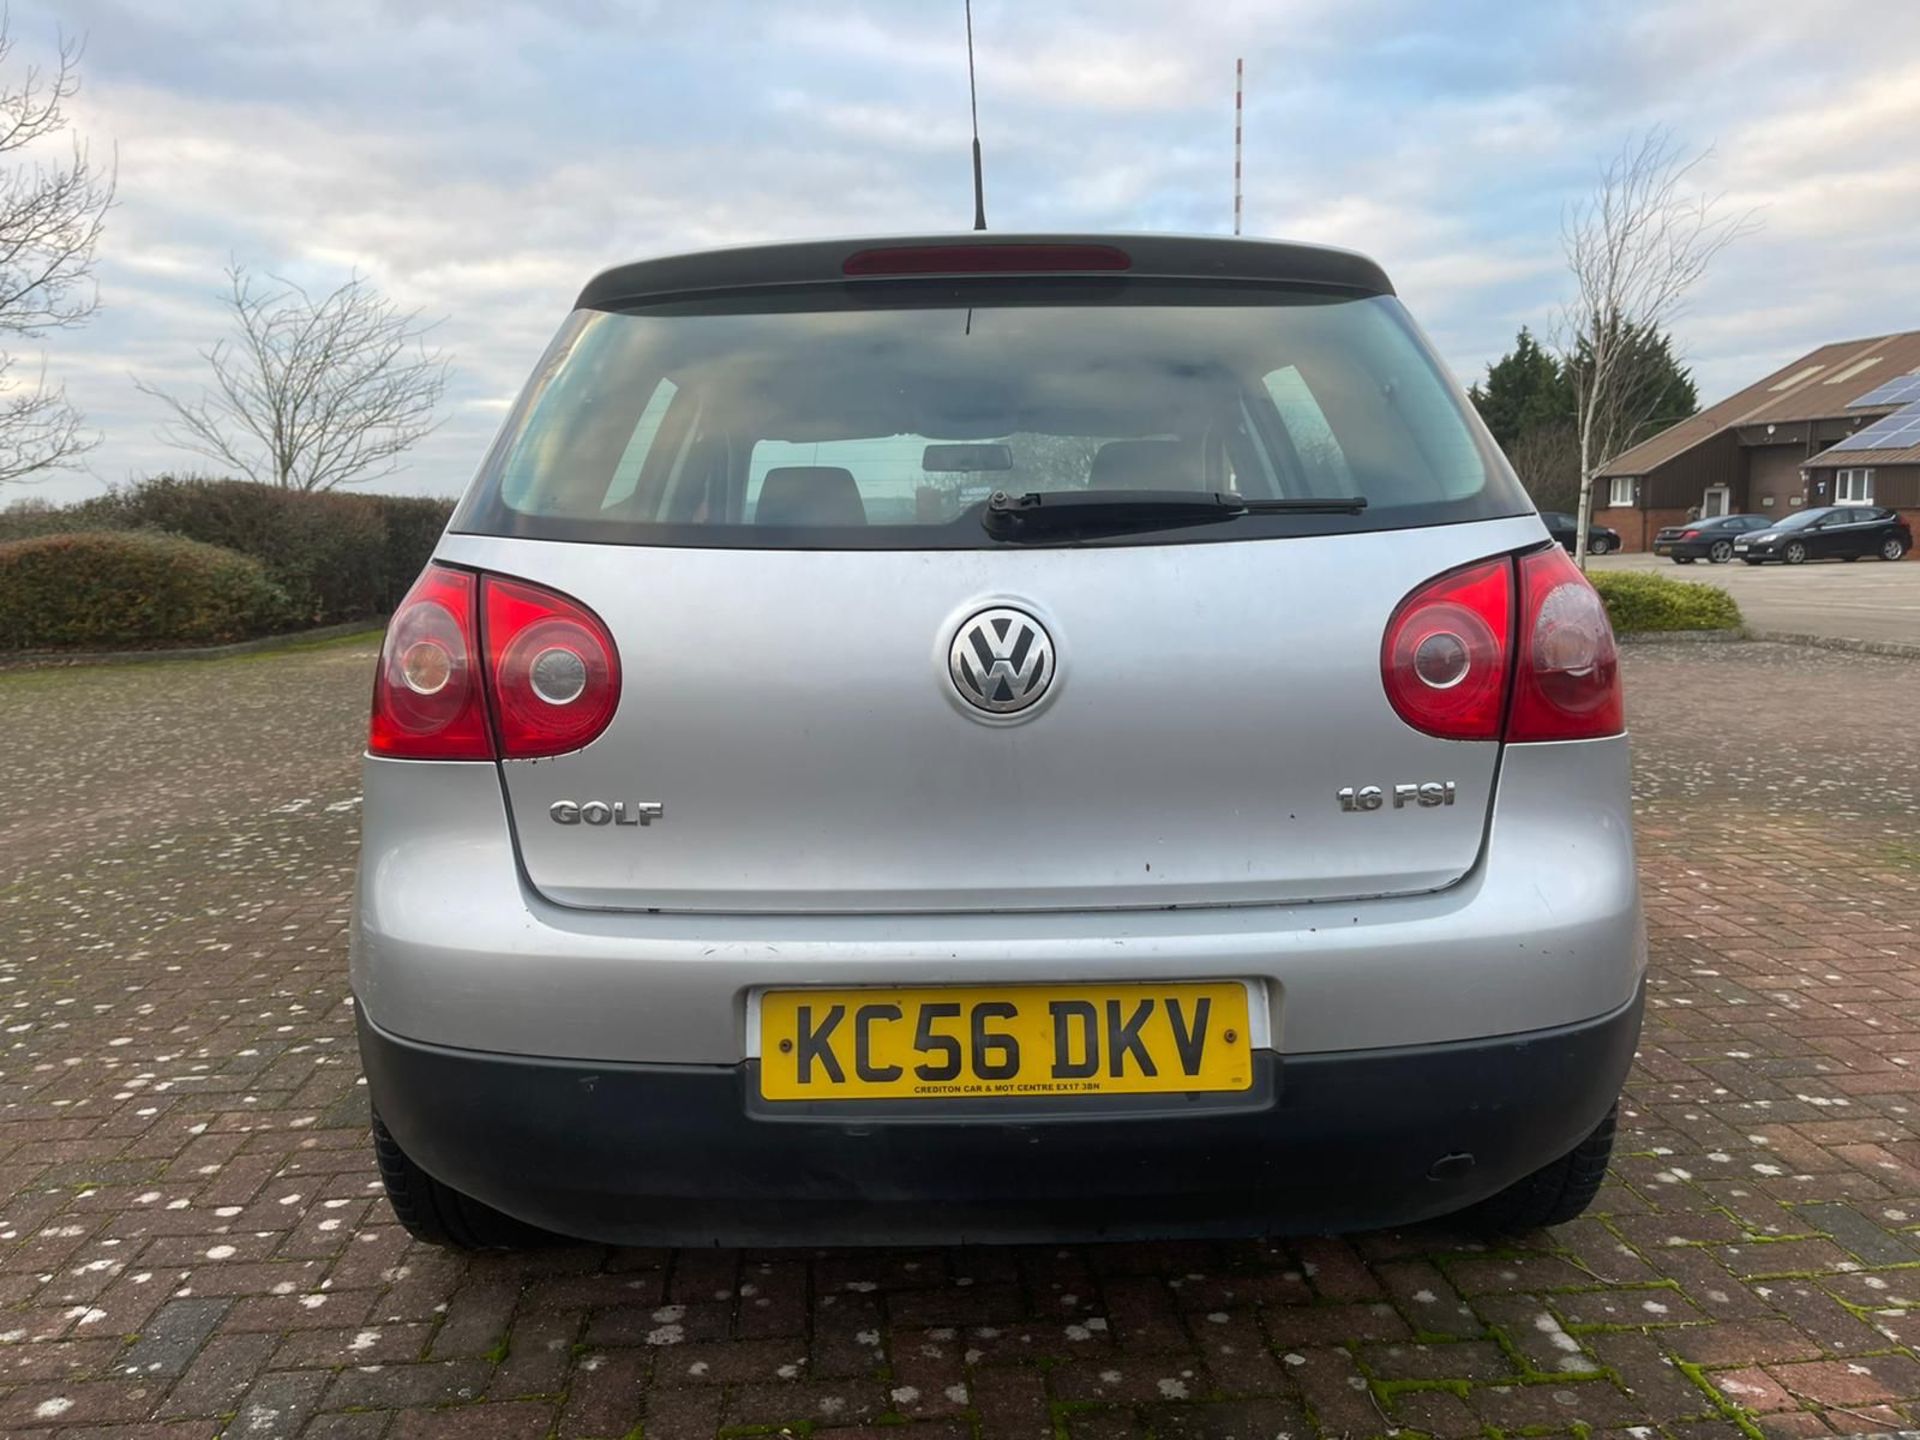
top-left (359, 991), bottom-right (1642, 1244)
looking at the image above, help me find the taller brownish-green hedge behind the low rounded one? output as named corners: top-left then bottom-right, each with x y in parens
top-left (0, 474), bottom-right (453, 628)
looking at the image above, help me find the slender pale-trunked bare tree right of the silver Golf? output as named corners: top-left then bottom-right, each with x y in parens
top-left (1555, 129), bottom-right (1755, 566)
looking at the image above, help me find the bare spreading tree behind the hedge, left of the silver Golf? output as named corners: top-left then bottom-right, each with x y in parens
top-left (134, 265), bottom-right (449, 490)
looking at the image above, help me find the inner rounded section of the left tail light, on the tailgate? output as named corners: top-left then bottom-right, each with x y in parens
top-left (480, 576), bottom-right (620, 760)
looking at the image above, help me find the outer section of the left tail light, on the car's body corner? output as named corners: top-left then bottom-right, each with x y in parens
top-left (367, 564), bottom-right (493, 760)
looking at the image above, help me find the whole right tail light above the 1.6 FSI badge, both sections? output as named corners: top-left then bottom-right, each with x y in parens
top-left (1380, 545), bottom-right (1626, 741)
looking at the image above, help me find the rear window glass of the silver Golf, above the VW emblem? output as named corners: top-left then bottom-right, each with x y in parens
top-left (453, 280), bottom-right (1528, 549)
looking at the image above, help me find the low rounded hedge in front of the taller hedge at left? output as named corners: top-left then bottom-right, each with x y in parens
top-left (0, 532), bottom-right (288, 651)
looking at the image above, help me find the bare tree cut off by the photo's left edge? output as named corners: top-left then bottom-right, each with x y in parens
top-left (0, 24), bottom-right (113, 484)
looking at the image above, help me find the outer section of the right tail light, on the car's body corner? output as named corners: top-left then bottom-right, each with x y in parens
top-left (1507, 545), bottom-right (1626, 741)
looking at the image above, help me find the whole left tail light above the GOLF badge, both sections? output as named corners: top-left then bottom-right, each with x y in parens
top-left (367, 564), bottom-right (620, 760)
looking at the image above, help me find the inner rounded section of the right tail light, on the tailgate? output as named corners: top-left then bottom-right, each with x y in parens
top-left (1380, 559), bottom-right (1513, 739)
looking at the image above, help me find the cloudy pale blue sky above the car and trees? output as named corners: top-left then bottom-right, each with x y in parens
top-left (11, 0), bottom-right (1920, 503)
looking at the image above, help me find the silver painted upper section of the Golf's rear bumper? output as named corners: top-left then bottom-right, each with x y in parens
top-left (353, 735), bottom-right (1645, 1068)
